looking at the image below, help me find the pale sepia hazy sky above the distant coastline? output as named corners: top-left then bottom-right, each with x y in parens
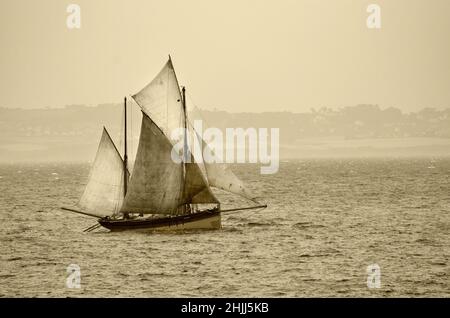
top-left (0, 0), bottom-right (450, 112)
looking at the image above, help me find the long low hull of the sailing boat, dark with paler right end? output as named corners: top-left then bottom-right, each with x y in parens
top-left (98, 211), bottom-right (222, 231)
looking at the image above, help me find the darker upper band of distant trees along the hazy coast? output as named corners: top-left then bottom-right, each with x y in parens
top-left (0, 104), bottom-right (450, 143)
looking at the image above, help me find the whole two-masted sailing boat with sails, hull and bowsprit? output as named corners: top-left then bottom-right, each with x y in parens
top-left (62, 56), bottom-right (267, 231)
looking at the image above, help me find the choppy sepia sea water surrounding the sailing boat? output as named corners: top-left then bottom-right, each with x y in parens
top-left (0, 159), bottom-right (450, 297)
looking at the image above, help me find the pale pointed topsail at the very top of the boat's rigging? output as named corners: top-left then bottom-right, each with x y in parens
top-left (133, 59), bottom-right (184, 143)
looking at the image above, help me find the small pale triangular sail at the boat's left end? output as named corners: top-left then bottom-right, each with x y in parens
top-left (78, 128), bottom-right (124, 216)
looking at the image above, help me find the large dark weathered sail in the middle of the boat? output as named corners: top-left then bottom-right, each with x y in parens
top-left (120, 113), bottom-right (184, 214)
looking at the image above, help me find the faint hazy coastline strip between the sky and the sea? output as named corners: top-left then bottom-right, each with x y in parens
top-left (0, 104), bottom-right (450, 163)
